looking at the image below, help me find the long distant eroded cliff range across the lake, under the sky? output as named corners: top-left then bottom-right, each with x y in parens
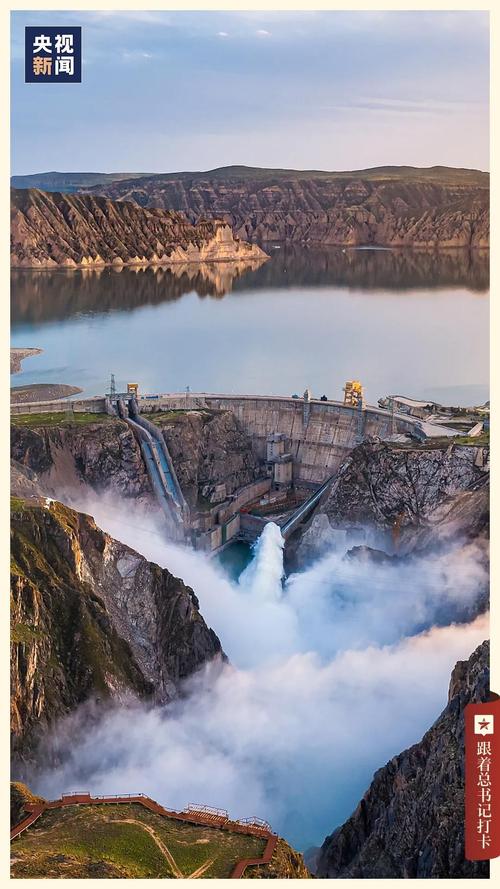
top-left (86, 167), bottom-right (489, 248)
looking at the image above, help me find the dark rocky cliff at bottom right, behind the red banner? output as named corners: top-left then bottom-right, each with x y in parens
top-left (317, 642), bottom-right (489, 879)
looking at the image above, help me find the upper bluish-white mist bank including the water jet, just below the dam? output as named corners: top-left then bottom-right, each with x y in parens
top-left (61, 495), bottom-right (488, 669)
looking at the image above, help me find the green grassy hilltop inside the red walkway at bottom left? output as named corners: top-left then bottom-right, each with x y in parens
top-left (12, 803), bottom-right (266, 879)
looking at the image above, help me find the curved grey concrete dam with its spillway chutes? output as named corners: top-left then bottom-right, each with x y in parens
top-left (13, 384), bottom-right (454, 552)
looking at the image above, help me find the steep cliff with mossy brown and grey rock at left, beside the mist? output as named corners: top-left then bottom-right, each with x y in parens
top-left (11, 498), bottom-right (222, 757)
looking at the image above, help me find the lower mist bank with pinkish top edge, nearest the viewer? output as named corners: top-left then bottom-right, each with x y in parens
top-left (28, 617), bottom-right (488, 849)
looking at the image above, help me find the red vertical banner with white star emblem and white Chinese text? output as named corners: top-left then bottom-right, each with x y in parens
top-left (464, 696), bottom-right (500, 861)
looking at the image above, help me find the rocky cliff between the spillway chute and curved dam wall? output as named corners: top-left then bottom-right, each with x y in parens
top-left (147, 410), bottom-right (262, 506)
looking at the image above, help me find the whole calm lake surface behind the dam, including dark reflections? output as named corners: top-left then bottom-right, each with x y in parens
top-left (12, 248), bottom-right (489, 404)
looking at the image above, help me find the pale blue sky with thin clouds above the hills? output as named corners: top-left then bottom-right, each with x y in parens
top-left (11, 11), bottom-right (489, 175)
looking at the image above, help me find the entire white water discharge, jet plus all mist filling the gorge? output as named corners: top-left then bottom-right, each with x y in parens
top-left (33, 500), bottom-right (488, 849)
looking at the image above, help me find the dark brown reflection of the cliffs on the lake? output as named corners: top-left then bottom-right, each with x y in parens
top-left (11, 246), bottom-right (489, 325)
